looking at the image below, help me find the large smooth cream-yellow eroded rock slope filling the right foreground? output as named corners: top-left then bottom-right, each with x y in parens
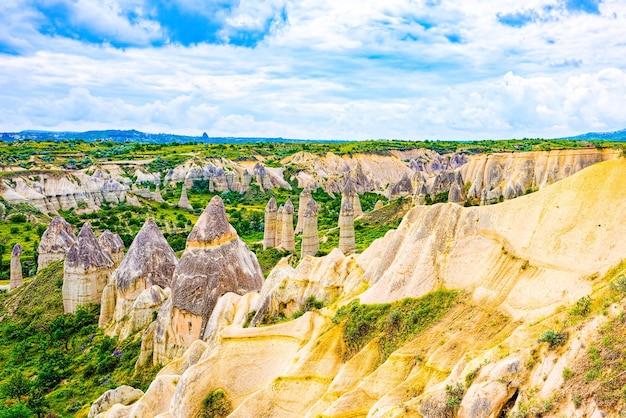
top-left (92, 160), bottom-right (626, 417)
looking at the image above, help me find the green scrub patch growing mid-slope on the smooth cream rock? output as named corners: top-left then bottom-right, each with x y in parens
top-left (333, 290), bottom-right (459, 362)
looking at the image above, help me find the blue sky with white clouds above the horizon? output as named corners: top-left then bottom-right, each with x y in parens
top-left (0, 0), bottom-right (626, 140)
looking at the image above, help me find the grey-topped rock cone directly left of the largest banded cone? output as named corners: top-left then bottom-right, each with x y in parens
top-left (100, 219), bottom-right (178, 339)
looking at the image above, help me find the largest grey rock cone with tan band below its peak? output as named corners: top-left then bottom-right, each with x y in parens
top-left (154, 196), bottom-right (263, 363)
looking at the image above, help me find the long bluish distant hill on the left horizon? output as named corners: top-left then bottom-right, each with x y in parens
top-left (0, 129), bottom-right (310, 144)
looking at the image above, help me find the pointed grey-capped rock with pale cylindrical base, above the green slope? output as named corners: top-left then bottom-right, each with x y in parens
top-left (62, 222), bottom-right (114, 313)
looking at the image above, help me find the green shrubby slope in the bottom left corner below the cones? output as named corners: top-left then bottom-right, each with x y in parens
top-left (0, 262), bottom-right (156, 417)
